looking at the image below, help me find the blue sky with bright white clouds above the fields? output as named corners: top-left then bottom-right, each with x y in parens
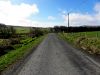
top-left (0, 0), bottom-right (100, 27)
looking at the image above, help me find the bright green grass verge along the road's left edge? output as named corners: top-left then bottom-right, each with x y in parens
top-left (0, 36), bottom-right (45, 71)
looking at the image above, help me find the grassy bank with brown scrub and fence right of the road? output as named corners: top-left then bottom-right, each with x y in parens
top-left (58, 31), bottom-right (100, 54)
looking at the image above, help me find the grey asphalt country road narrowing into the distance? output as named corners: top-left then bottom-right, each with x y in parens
top-left (17, 33), bottom-right (100, 75)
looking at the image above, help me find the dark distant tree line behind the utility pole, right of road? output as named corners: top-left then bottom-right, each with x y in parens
top-left (53, 26), bottom-right (100, 32)
